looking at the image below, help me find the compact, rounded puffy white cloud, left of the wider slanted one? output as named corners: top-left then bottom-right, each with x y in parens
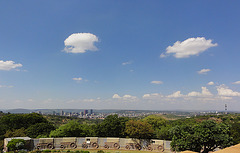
top-left (64, 33), bottom-right (98, 53)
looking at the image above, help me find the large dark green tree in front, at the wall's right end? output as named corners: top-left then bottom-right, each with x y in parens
top-left (170, 120), bottom-right (232, 153)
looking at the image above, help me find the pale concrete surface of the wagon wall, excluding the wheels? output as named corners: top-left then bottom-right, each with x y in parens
top-left (4, 137), bottom-right (170, 150)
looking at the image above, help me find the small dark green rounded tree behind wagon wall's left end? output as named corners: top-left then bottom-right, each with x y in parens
top-left (26, 123), bottom-right (55, 138)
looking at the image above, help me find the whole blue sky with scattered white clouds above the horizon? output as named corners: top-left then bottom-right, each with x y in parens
top-left (0, 0), bottom-right (240, 110)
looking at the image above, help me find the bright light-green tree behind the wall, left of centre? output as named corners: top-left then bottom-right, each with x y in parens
top-left (49, 121), bottom-right (90, 137)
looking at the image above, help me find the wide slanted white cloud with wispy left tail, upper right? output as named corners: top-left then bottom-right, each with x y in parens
top-left (160, 37), bottom-right (218, 58)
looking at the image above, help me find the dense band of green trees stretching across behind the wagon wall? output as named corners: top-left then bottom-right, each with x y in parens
top-left (0, 113), bottom-right (240, 152)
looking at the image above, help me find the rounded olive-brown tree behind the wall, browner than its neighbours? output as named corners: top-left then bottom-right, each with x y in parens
top-left (125, 120), bottom-right (154, 139)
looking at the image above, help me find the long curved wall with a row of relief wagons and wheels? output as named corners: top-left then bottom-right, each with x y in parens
top-left (4, 137), bottom-right (170, 151)
